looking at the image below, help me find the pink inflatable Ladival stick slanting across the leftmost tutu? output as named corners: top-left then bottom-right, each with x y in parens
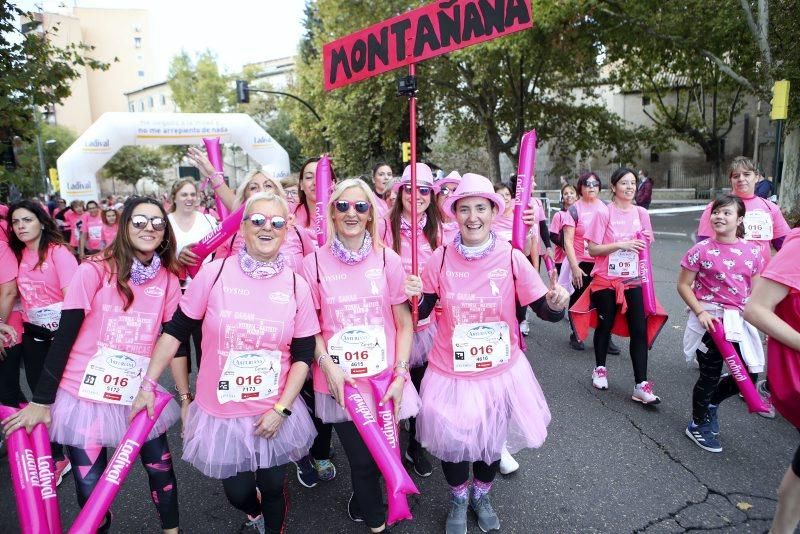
top-left (69, 391), bottom-right (172, 534)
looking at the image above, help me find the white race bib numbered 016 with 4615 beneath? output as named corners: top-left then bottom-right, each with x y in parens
top-left (328, 325), bottom-right (387, 378)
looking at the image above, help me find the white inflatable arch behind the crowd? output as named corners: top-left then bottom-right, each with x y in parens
top-left (57, 112), bottom-right (289, 202)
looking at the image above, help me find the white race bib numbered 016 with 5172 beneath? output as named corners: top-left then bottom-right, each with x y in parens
top-left (78, 347), bottom-right (150, 406)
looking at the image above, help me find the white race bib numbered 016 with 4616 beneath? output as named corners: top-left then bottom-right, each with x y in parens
top-left (453, 321), bottom-right (511, 373)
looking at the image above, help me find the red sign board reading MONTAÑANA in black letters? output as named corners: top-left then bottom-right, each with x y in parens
top-left (322, 0), bottom-right (533, 91)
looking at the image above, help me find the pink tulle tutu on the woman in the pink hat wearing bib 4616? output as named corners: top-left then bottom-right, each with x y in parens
top-left (417, 357), bottom-right (550, 464)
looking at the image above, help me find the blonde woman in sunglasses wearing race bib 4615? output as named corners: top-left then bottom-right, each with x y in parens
top-left (303, 179), bottom-right (419, 532)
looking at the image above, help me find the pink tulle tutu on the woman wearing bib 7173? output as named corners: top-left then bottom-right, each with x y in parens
top-left (183, 395), bottom-right (317, 479)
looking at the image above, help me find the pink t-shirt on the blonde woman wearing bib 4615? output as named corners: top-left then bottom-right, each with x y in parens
top-left (303, 243), bottom-right (408, 393)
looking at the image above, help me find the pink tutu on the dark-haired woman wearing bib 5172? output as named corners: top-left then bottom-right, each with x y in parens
top-left (50, 388), bottom-right (181, 449)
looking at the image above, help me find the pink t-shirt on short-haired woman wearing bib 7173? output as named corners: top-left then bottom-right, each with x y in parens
top-left (180, 259), bottom-right (319, 418)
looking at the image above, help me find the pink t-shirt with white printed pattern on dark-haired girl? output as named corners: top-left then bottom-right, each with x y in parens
top-left (681, 238), bottom-right (764, 310)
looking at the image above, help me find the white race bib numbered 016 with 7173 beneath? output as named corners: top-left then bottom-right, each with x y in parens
top-left (217, 349), bottom-right (281, 404)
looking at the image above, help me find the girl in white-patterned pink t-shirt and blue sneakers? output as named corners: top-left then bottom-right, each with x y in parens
top-left (678, 195), bottom-right (764, 452)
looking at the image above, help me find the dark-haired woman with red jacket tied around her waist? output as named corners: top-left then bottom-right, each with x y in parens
top-left (570, 167), bottom-right (666, 404)
